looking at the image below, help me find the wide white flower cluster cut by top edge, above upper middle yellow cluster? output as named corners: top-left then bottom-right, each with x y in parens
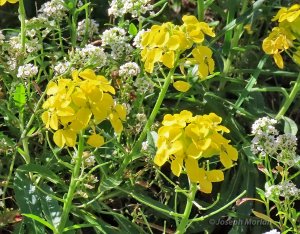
top-left (108, 0), bottom-right (153, 18)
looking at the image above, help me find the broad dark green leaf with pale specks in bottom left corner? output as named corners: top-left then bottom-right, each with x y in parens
top-left (13, 170), bottom-right (46, 234)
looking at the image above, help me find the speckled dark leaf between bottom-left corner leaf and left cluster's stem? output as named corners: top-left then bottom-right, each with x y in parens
top-left (40, 184), bottom-right (62, 228)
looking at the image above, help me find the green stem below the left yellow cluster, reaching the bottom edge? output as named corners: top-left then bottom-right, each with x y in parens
top-left (57, 133), bottom-right (84, 234)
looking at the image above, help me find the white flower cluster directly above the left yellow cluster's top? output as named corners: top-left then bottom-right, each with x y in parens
top-left (69, 44), bottom-right (107, 69)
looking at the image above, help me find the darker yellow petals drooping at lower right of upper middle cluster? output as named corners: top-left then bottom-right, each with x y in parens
top-left (191, 46), bottom-right (215, 79)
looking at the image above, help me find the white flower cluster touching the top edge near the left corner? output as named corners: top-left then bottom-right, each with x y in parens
top-left (38, 0), bottom-right (68, 21)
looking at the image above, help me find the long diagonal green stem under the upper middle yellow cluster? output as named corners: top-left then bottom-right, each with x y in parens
top-left (116, 63), bottom-right (177, 177)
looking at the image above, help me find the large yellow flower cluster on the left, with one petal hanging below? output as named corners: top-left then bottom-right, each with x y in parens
top-left (42, 69), bottom-right (126, 148)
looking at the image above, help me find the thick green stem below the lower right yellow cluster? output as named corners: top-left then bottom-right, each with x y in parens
top-left (175, 183), bottom-right (197, 234)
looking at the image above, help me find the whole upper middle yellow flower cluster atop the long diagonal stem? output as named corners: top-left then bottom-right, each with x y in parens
top-left (141, 15), bottom-right (215, 81)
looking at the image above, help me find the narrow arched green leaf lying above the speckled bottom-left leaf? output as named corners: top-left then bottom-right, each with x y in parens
top-left (17, 164), bottom-right (64, 184)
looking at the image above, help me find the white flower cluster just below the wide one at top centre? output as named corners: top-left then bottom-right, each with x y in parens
top-left (101, 27), bottom-right (127, 46)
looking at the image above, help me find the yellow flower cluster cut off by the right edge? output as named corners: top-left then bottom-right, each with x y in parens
top-left (262, 4), bottom-right (300, 69)
